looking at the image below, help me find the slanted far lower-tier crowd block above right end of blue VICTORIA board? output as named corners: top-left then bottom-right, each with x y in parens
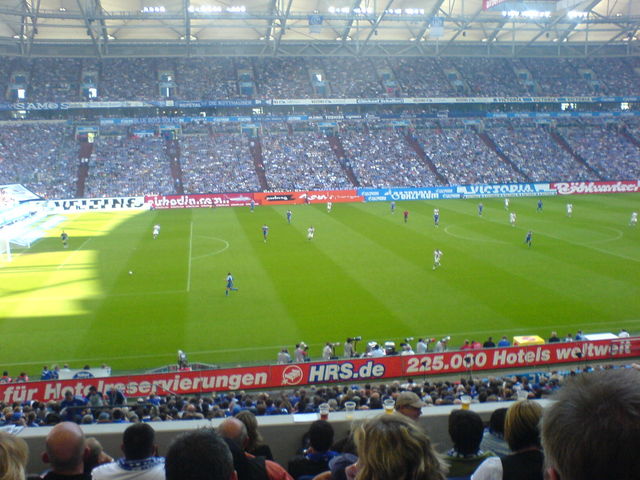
top-left (488, 126), bottom-right (597, 182)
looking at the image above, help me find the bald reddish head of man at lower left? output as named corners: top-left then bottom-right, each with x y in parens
top-left (42, 422), bottom-right (89, 475)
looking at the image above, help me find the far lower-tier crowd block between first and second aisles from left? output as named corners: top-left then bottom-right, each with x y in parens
top-left (85, 136), bottom-right (175, 197)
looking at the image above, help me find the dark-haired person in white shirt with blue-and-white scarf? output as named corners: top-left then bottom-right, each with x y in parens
top-left (91, 423), bottom-right (164, 480)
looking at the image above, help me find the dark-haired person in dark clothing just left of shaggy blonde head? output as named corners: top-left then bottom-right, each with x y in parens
top-left (287, 420), bottom-right (338, 479)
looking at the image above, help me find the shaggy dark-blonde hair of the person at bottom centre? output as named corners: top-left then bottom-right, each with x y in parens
top-left (355, 413), bottom-right (446, 480)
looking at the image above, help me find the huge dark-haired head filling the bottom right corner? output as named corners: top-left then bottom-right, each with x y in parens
top-left (542, 369), bottom-right (640, 480)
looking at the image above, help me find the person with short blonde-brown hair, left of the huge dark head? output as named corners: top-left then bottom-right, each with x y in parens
top-left (471, 400), bottom-right (544, 480)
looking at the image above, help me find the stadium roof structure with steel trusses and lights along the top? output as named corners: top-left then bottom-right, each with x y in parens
top-left (0, 0), bottom-right (640, 57)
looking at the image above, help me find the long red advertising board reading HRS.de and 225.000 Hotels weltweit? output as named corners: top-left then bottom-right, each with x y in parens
top-left (0, 337), bottom-right (640, 403)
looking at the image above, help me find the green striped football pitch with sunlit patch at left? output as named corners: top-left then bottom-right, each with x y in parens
top-left (0, 194), bottom-right (640, 375)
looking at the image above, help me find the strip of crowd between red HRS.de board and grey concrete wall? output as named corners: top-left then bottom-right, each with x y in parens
top-left (0, 365), bottom-right (627, 427)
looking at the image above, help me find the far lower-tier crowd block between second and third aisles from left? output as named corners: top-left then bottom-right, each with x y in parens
top-left (179, 133), bottom-right (260, 193)
